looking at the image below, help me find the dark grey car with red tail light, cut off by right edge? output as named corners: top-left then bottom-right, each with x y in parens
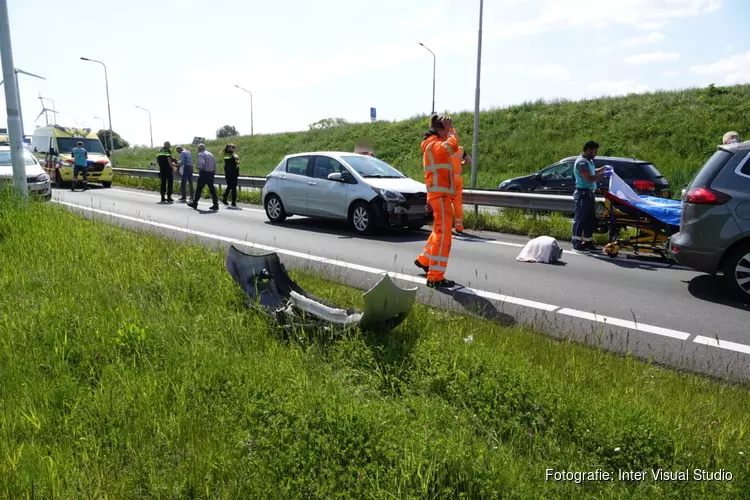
top-left (669, 141), bottom-right (750, 300)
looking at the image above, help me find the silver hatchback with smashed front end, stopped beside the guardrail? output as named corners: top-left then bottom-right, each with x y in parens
top-left (262, 151), bottom-right (433, 234)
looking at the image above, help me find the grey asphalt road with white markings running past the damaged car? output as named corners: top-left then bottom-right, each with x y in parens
top-left (53, 188), bottom-right (750, 380)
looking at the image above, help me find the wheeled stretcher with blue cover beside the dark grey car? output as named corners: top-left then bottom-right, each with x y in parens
top-left (597, 174), bottom-right (682, 262)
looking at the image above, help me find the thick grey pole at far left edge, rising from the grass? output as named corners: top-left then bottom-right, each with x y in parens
top-left (0, 0), bottom-right (29, 200)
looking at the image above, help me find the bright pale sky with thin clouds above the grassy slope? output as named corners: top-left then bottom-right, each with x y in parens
top-left (0, 0), bottom-right (750, 144)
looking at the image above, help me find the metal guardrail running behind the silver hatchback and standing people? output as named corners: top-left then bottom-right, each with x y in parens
top-left (112, 168), bottom-right (604, 213)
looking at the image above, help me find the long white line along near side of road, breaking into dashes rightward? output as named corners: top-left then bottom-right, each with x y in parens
top-left (53, 196), bottom-right (750, 360)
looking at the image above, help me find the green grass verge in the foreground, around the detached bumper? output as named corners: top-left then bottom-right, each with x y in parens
top-left (0, 192), bottom-right (750, 499)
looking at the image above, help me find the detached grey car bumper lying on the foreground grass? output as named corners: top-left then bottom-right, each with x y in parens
top-left (226, 246), bottom-right (417, 329)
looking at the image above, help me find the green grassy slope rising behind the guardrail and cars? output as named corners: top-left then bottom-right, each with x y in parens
top-left (115, 85), bottom-right (750, 239)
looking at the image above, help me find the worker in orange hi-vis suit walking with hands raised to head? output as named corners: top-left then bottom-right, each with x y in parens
top-left (414, 115), bottom-right (459, 288)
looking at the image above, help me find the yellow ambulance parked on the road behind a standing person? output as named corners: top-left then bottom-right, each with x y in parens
top-left (32, 125), bottom-right (113, 188)
